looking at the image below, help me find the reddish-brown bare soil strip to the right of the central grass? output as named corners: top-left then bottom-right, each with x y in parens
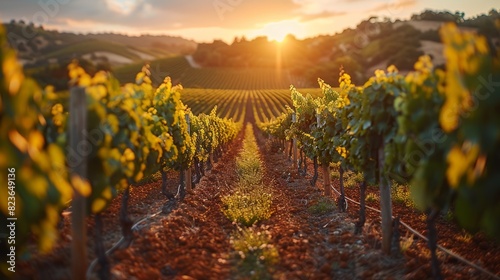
top-left (261, 141), bottom-right (403, 279)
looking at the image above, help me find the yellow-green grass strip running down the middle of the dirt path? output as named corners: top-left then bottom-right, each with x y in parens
top-left (221, 124), bottom-right (279, 279)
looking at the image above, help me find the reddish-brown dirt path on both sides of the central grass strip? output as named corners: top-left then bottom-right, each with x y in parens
top-left (103, 128), bottom-right (403, 279)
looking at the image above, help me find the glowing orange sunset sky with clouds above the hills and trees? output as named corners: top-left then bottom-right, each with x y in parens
top-left (0, 0), bottom-right (500, 42)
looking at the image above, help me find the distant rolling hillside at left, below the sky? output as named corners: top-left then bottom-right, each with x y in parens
top-left (4, 21), bottom-right (197, 68)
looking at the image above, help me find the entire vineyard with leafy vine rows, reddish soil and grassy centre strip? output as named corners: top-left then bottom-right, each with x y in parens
top-left (0, 15), bottom-right (500, 279)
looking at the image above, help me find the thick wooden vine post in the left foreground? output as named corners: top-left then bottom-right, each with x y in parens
top-left (69, 87), bottom-right (87, 280)
